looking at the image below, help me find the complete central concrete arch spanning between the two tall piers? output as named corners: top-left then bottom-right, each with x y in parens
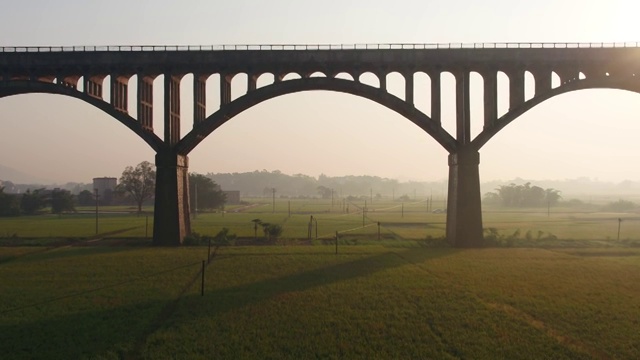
top-left (177, 77), bottom-right (457, 155)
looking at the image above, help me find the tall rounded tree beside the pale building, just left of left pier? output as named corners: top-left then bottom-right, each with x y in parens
top-left (118, 161), bottom-right (156, 213)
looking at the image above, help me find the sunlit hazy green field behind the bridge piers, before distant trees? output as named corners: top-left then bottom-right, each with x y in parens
top-left (0, 198), bottom-right (640, 246)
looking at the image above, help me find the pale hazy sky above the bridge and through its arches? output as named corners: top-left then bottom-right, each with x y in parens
top-left (0, 0), bottom-right (640, 182)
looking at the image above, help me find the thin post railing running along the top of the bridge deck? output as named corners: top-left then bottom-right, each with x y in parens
top-left (0, 42), bottom-right (640, 53)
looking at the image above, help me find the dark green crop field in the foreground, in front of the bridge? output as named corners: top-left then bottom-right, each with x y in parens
top-left (0, 245), bottom-right (640, 359)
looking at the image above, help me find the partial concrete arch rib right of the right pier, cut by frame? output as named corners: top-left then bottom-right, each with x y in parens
top-left (471, 76), bottom-right (640, 150)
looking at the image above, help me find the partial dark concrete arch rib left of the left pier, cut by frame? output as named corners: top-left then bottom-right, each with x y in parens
top-left (0, 80), bottom-right (164, 152)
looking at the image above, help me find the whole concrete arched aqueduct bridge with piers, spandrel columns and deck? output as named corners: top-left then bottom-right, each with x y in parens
top-left (0, 43), bottom-right (640, 247)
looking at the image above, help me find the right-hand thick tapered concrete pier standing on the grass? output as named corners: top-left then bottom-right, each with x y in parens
top-left (447, 146), bottom-right (484, 248)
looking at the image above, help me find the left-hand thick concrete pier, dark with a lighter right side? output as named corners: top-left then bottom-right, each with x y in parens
top-left (153, 150), bottom-right (191, 246)
